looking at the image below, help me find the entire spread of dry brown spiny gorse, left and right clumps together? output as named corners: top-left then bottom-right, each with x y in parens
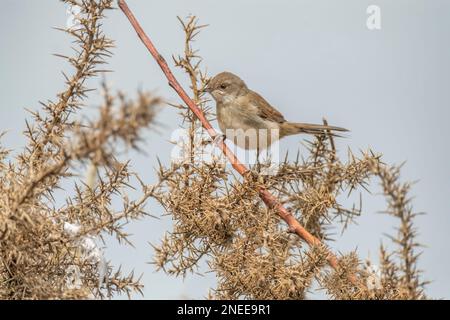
top-left (0, 0), bottom-right (425, 299)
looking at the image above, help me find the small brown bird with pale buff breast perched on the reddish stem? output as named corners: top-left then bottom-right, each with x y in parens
top-left (205, 72), bottom-right (348, 150)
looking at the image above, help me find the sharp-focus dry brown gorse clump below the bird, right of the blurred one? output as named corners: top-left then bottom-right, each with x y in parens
top-left (149, 17), bottom-right (425, 299)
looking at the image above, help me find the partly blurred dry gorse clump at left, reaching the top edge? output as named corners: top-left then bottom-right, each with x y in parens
top-left (0, 0), bottom-right (160, 299)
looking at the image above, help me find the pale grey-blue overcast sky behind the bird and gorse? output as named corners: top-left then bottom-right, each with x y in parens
top-left (0, 0), bottom-right (450, 299)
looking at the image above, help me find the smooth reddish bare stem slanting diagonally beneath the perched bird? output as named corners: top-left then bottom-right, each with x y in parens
top-left (119, 0), bottom-right (338, 269)
